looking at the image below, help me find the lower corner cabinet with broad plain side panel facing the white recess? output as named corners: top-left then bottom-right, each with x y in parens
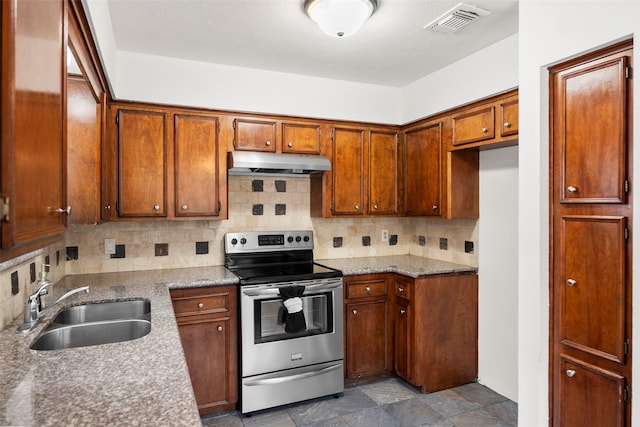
top-left (394, 273), bottom-right (478, 393)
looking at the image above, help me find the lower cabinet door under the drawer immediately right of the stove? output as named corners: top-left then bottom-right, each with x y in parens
top-left (345, 299), bottom-right (389, 380)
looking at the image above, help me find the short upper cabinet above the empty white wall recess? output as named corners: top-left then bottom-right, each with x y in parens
top-left (451, 90), bottom-right (518, 150)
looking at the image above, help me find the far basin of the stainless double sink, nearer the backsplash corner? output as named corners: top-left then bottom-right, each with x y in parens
top-left (53, 299), bottom-right (151, 325)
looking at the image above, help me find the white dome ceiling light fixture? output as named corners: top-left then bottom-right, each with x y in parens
top-left (304, 0), bottom-right (378, 37)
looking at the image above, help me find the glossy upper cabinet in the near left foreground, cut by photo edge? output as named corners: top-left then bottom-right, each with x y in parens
top-left (0, 0), bottom-right (68, 259)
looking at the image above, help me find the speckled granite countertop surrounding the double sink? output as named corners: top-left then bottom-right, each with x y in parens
top-left (0, 267), bottom-right (238, 426)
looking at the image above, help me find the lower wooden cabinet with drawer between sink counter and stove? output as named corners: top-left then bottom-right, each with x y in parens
top-left (171, 286), bottom-right (238, 415)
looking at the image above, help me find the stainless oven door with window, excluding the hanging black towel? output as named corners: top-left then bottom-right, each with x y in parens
top-left (240, 278), bottom-right (344, 377)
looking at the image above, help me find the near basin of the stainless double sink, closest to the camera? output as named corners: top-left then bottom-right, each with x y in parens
top-left (31, 319), bottom-right (151, 350)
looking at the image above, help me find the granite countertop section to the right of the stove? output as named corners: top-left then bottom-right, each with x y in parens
top-left (316, 255), bottom-right (478, 279)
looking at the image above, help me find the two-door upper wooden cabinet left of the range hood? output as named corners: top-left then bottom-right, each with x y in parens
top-left (103, 104), bottom-right (227, 220)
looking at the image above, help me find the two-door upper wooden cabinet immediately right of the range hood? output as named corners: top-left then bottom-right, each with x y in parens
top-left (311, 126), bottom-right (401, 217)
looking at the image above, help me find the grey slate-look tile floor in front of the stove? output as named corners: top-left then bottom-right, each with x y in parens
top-left (202, 378), bottom-right (518, 427)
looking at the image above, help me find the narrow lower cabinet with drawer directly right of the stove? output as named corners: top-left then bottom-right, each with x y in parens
top-left (344, 275), bottom-right (392, 383)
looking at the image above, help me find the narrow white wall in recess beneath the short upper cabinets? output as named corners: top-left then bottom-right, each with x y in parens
top-left (478, 146), bottom-right (518, 402)
